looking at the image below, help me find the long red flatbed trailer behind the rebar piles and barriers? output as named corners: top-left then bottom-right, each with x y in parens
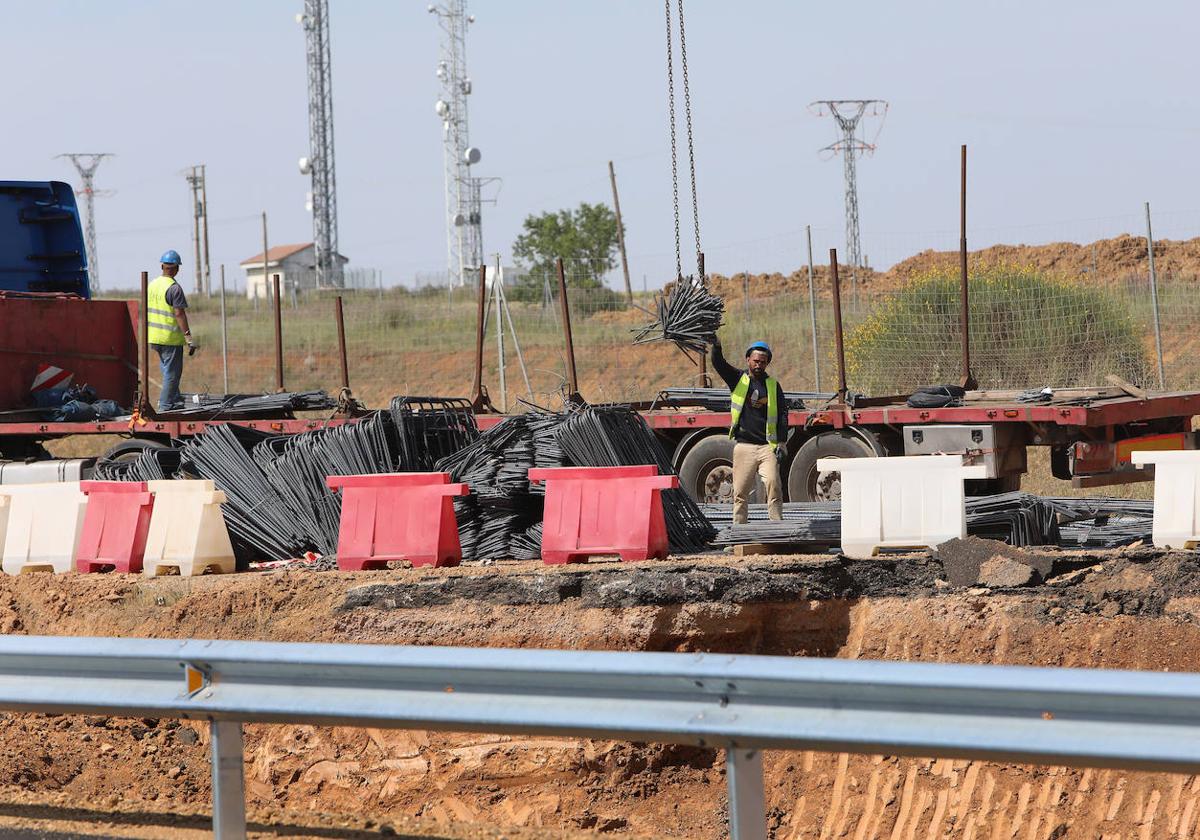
top-left (0, 295), bottom-right (1200, 500)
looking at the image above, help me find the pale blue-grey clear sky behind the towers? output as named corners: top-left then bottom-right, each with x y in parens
top-left (0, 0), bottom-right (1200, 287)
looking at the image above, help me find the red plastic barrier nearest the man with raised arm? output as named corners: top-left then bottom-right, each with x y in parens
top-left (529, 466), bottom-right (679, 563)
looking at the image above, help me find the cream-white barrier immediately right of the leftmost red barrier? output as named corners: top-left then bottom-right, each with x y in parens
top-left (143, 481), bottom-right (236, 577)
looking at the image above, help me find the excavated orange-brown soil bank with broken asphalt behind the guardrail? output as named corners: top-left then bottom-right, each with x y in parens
top-left (0, 551), bottom-right (1200, 840)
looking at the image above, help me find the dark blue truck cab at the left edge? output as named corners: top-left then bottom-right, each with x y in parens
top-left (0, 181), bottom-right (91, 298)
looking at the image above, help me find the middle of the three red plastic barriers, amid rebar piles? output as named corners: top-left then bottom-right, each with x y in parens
top-left (325, 473), bottom-right (467, 571)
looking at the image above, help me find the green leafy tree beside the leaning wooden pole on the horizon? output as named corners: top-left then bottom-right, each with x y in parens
top-left (512, 202), bottom-right (617, 308)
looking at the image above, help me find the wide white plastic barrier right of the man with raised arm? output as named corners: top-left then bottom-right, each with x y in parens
top-left (817, 455), bottom-right (988, 558)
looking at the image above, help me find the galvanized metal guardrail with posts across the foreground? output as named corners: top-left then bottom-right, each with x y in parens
top-left (0, 636), bottom-right (1200, 840)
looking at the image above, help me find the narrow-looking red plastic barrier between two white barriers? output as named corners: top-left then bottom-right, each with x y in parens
top-left (76, 481), bottom-right (154, 574)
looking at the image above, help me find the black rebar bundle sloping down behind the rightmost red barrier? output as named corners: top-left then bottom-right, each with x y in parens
top-left (554, 407), bottom-right (716, 552)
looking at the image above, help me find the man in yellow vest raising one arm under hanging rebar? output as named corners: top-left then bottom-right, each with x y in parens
top-left (713, 338), bottom-right (787, 523)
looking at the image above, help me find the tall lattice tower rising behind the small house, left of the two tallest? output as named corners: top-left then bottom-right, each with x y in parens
top-left (296, 0), bottom-right (342, 288)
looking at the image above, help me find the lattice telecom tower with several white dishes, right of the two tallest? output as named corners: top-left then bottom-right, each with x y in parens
top-left (428, 0), bottom-right (484, 284)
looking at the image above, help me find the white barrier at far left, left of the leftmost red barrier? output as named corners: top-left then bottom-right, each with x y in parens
top-left (0, 481), bottom-right (88, 575)
